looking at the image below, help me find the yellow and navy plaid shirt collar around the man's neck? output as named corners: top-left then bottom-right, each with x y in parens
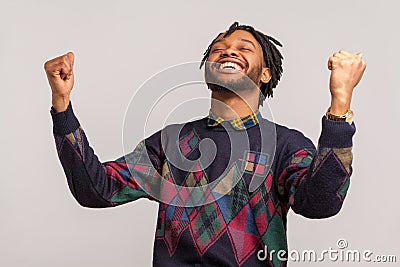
top-left (207, 109), bottom-right (262, 130)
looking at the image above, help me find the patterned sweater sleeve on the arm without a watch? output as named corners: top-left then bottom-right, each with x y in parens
top-left (50, 103), bottom-right (160, 208)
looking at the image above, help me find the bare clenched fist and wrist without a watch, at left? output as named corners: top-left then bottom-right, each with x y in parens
top-left (44, 52), bottom-right (74, 112)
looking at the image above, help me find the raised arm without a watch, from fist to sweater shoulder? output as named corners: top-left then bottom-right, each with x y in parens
top-left (45, 52), bottom-right (160, 207)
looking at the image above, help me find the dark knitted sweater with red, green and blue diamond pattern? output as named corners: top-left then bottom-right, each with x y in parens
top-left (51, 104), bottom-right (355, 267)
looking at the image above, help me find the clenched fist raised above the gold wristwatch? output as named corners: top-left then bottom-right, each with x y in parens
top-left (328, 50), bottom-right (366, 115)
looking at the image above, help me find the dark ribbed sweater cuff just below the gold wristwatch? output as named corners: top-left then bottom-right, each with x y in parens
top-left (318, 116), bottom-right (356, 148)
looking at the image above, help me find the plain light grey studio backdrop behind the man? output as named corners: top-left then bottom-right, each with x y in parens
top-left (0, 0), bottom-right (400, 267)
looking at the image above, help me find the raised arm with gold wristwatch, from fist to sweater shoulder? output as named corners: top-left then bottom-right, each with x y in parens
top-left (278, 50), bottom-right (366, 218)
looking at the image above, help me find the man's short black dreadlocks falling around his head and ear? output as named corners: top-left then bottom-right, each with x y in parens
top-left (200, 22), bottom-right (283, 101)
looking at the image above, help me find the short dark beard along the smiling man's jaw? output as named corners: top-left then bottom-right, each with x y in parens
top-left (205, 62), bottom-right (262, 92)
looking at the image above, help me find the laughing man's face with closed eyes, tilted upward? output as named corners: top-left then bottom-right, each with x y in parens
top-left (205, 30), bottom-right (269, 91)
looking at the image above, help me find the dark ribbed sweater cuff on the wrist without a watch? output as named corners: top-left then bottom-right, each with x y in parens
top-left (50, 102), bottom-right (80, 135)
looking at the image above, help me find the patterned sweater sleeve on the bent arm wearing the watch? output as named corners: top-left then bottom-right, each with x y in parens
top-left (278, 116), bottom-right (355, 218)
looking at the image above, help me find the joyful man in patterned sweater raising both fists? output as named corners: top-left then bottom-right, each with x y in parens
top-left (45, 23), bottom-right (366, 266)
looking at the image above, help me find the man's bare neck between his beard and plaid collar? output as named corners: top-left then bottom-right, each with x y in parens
top-left (211, 90), bottom-right (260, 120)
